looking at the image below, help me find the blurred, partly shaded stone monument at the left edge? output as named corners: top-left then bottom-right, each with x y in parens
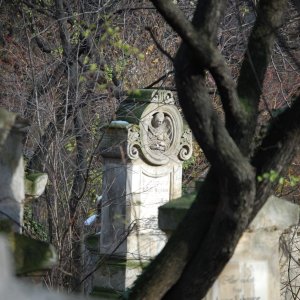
top-left (0, 108), bottom-right (57, 280)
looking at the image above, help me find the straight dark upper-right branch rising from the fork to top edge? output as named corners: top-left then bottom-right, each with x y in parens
top-left (237, 0), bottom-right (287, 152)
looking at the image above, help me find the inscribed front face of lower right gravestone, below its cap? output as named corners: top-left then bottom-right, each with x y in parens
top-left (205, 229), bottom-right (280, 300)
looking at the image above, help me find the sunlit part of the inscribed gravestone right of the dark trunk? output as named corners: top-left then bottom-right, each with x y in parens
top-left (205, 197), bottom-right (299, 300)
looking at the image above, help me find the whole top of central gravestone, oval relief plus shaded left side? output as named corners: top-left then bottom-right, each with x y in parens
top-left (99, 90), bottom-right (192, 166)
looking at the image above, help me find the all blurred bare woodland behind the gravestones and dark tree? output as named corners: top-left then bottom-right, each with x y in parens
top-left (0, 0), bottom-right (300, 290)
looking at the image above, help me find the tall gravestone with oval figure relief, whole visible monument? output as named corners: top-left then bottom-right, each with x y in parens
top-left (94, 90), bottom-right (192, 291)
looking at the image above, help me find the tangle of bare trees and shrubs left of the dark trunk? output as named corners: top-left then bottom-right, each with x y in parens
top-left (0, 0), bottom-right (192, 290)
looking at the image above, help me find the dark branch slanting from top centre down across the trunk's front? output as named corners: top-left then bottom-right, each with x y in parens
top-left (152, 0), bottom-right (247, 149)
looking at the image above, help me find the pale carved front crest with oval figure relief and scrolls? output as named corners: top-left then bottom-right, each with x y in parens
top-left (127, 91), bottom-right (192, 165)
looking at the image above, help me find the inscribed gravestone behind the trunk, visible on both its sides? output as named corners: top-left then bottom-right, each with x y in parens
top-left (159, 195), bottom-right (300, 300)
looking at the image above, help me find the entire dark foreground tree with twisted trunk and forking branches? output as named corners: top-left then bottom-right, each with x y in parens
top-left (127, 0), bottom-right (300, 300)
